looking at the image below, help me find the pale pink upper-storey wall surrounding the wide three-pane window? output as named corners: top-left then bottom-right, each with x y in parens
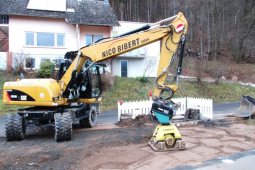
top-left (9, 16), bottom-right (77, 54)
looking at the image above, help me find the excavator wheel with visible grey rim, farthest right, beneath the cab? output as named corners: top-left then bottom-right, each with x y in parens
top-left (80, 107), bottom-right (97, 128)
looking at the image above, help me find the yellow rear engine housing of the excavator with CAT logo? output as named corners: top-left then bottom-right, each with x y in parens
top-left (3, 79), bottom-right (64, 106)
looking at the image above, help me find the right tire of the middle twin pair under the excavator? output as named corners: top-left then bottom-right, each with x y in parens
top-left (62, 112), bottom-right (72, 141)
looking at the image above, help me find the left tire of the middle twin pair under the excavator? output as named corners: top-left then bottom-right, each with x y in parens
top-left (54, 113), bottom-right (65, 142)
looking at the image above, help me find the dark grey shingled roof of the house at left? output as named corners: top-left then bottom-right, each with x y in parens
top-left (0, 0), bottom-right (119, 26)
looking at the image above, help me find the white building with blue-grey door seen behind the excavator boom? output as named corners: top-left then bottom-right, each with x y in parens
top-left (112, 21), bottom-right (160, 77)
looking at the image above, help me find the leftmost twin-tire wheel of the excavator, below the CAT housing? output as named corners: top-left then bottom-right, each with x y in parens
top-left (5, 114), bottom-right (26, 141)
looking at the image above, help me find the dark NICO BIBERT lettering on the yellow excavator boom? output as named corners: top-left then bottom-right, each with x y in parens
top-left (102, 38), bottom-right (139, 57)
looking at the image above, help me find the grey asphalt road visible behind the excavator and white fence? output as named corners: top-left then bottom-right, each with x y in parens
top-left (0, 102), bottom-right (240, 137)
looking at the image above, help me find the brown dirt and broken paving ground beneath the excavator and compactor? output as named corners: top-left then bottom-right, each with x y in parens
top-left (0, 118), bottom-right (255, 170)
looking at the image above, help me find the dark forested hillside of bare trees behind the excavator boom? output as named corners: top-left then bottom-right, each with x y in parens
top-left (110, 0), bottom-right (255, 63)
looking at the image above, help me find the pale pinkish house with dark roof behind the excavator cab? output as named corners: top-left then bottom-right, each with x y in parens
top-left (0, 0), bottom-right (119, 69)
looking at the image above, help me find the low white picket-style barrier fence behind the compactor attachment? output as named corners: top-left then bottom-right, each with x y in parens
top-left (118, 97), bottom-right (213, 121)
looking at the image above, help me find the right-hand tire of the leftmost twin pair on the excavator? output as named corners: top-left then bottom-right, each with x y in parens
top-left (13, 114), bottom-right (25, 140)
